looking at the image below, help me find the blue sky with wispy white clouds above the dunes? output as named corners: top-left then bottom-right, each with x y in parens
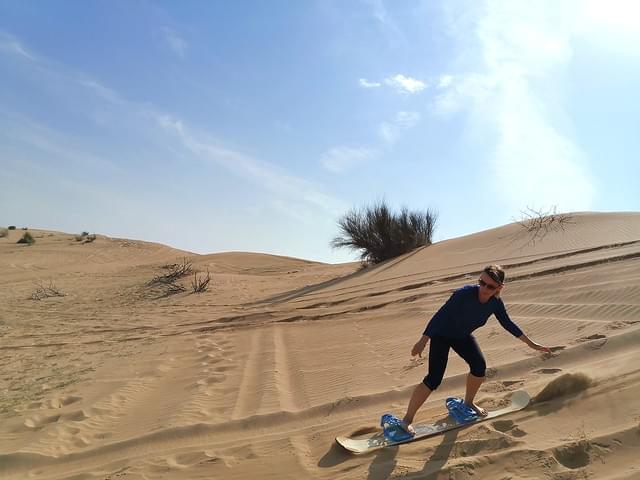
top-left (0, 0), bottom-right (640, 263)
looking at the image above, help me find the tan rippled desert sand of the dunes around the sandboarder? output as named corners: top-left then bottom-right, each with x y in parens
top-left (0, 213), bottom-right (640, 480)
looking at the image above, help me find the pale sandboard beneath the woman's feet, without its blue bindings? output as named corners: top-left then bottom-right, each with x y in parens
top-left (336, 390), bottom-right (531, 453)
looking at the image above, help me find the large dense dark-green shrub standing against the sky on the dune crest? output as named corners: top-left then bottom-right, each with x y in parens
top-left (331, 201), bottom-right (438, 263)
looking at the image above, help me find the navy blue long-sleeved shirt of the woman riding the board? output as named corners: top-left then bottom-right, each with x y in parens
top-left (424, 285), bottom-right (522, 338)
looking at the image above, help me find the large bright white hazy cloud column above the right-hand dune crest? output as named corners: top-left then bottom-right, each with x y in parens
top-left (435, 1), bottom-right (595, 211)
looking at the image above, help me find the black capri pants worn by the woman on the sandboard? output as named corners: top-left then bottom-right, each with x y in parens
top-left (422, 335), bottom-right (487, 390)
